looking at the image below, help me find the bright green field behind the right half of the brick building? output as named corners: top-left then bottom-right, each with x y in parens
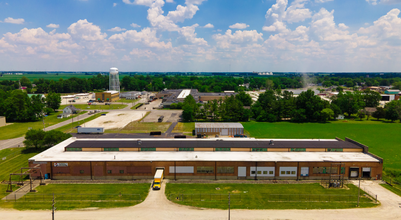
top-left (242, 121), bottom-right (401, 170)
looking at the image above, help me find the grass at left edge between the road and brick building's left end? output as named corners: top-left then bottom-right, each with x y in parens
top-left (0, 148), bottom-right (44, 182)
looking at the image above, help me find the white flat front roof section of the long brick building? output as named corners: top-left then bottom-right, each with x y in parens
top-left (29, 138), bottom-right (380, 162)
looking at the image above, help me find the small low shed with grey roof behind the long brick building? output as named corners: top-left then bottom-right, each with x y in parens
top-left (195, 123), bottom-right (244, 136)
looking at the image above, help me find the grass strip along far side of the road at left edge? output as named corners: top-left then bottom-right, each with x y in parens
top-left (0, 112), bottom-right (85, 140)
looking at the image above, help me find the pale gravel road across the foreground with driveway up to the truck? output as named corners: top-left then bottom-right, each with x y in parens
top-left (0, 181), bottom-right (401, 220)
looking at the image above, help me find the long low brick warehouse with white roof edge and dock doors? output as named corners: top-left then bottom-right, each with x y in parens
top-left (29, 137), bottom-right (383, 180)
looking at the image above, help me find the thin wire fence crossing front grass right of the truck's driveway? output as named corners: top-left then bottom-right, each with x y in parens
top-left (167, 193), bottom-right (375, 203)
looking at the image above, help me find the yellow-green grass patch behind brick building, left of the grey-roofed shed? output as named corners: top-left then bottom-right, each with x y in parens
top-left (105, 121), bottom-right (171, 134)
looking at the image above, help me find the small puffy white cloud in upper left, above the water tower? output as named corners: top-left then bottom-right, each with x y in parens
top-left (68, 19), bottom-right (107, 41)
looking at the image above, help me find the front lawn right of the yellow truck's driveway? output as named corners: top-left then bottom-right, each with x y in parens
top-left (166, 183), bottom-right (376, 209)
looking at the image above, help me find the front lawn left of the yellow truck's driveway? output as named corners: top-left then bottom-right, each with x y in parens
top-left (0, 183), bottom-right (150, 210)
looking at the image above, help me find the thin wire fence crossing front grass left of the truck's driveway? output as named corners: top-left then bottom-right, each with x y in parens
top-left (1, 193), bottom-right (144, 202)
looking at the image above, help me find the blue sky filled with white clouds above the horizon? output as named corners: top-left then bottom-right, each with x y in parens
top-left (0, 0), bottom-right (401, 72)
